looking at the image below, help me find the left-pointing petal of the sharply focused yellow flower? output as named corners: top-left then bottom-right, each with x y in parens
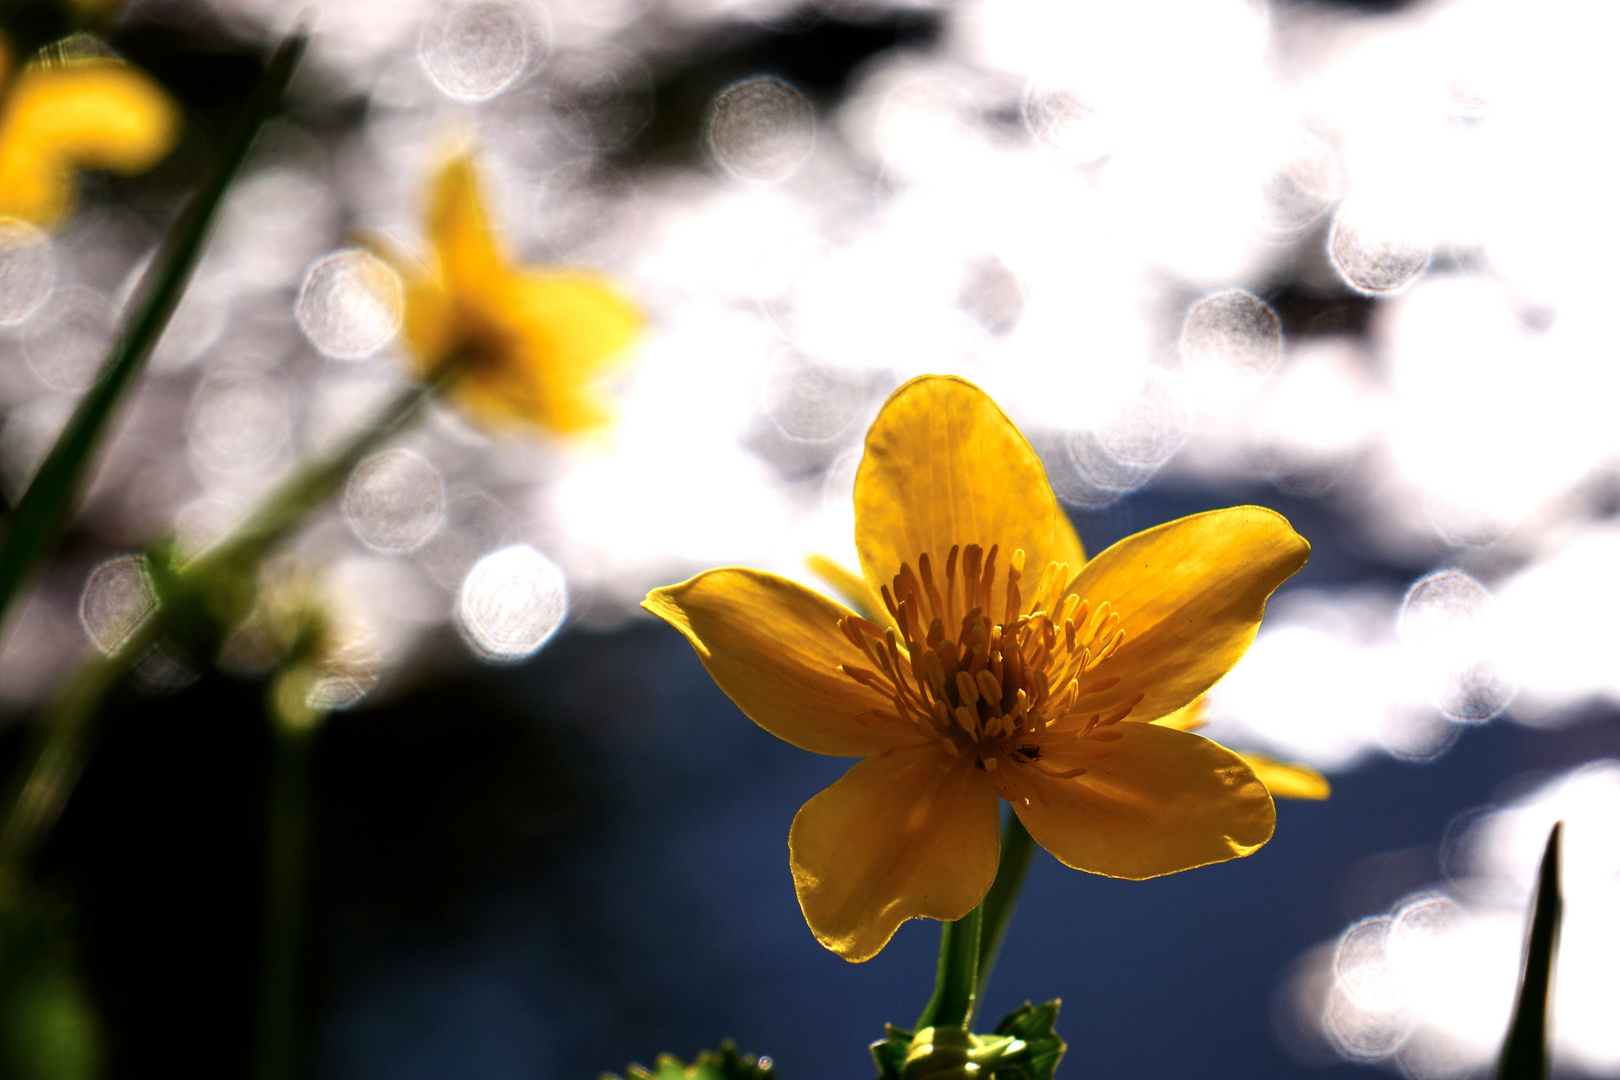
top-left (642, 568), bottom-right (915, 758)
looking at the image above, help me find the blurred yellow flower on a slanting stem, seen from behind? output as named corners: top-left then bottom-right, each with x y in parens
top-left (405, 155), bottom-right (642, 436)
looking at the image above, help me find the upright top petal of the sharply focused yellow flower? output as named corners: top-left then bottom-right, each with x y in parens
top-left (855, 376), bottom-right (1084, 620)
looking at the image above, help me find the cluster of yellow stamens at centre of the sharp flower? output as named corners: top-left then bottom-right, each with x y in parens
top-left (839, 544), bottom-right (1142, 803)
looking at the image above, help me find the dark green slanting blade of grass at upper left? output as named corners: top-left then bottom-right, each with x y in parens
top-left (0, 34), bottom-right (308, 641)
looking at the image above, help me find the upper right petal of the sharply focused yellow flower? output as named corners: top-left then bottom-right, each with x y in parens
top-left (1069, 507), bottom-right (1311, 721)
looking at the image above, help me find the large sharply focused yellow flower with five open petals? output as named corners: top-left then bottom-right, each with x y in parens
top-left (643, 376), bottom-right (1309, 960)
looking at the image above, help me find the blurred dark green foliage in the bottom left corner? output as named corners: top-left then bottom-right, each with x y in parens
top-left (0, 897), bottom-right (102, 1080)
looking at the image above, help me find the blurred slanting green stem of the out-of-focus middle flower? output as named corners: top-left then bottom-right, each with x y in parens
top-left (0, 375), bottom-right (454, 878)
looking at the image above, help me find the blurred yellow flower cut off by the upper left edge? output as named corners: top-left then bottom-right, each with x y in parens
top-left (0, 39), bottom-right (180, 227)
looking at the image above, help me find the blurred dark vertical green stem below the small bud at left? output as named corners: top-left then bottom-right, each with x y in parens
top-left (256, 706), bottom-right (319, 1080)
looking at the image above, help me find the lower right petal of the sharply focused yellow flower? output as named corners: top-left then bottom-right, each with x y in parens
top-left (1013, 724), bottom-right (1277, 881)
